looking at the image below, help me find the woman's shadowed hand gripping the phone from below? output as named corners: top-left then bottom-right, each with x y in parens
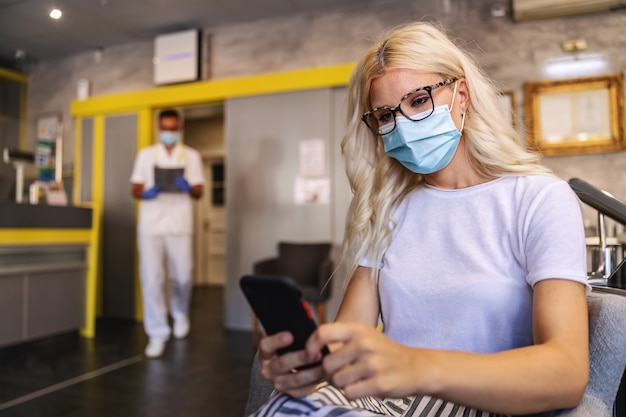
top-left (257, 332), bottom-right (324, 397)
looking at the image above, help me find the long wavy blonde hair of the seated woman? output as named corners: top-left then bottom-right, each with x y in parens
top-left (341, 22), bottom-right (550, 282)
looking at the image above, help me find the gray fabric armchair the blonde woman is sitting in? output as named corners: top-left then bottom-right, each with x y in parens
top-left (246, 292), bottom-right (626, 417)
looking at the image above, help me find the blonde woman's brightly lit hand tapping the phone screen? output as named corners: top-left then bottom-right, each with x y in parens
top-left (307, 323), bottom-right (424, 399)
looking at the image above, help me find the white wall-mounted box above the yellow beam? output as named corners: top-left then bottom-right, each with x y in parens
top-left (153, 29), bottom-right (200, 85)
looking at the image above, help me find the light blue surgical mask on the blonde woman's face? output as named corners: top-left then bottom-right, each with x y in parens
top-left (382, 88), bottom-right (465, 174)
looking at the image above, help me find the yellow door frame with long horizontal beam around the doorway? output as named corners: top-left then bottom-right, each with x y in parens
top-left (70, 63), bottom-right (354, 336)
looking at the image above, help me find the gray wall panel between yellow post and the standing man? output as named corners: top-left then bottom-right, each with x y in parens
top-left (102, 114), bottom-right (137, 318)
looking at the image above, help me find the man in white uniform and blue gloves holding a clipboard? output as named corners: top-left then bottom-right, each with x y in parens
top-left (130, 110), bottom-right (204, 358)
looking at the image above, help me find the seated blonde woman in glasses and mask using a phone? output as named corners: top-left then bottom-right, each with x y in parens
top-left (251, 23), bottom-right (589, 417)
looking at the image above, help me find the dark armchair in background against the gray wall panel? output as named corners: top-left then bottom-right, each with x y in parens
top-left (252, 242), bottom-right (333, 346)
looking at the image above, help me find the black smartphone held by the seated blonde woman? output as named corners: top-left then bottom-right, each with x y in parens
top-left (239, 275), bottom-right (328, 369)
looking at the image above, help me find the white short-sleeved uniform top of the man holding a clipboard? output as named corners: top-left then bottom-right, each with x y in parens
top-left (130, 144), bottom-right (204, 235)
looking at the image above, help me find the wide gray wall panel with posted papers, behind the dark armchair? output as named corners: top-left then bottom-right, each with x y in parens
top-left (225, 89), bottom-right (352, 328)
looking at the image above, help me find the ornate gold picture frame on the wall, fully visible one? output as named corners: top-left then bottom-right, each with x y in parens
top-left (524, 73), bottom-right (626, 155)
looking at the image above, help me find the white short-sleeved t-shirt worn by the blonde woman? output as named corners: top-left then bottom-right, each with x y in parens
top-left (366, 175), bottom-right (590, 353)
